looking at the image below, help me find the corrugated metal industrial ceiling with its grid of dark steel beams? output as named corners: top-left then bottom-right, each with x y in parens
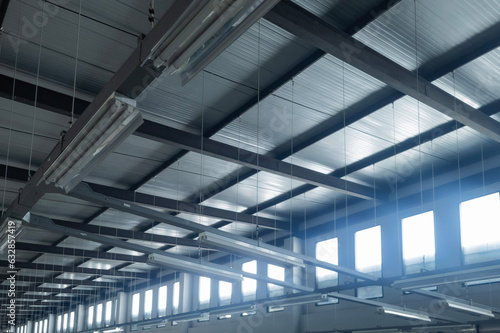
top-left (0, 0), bottom-right (500, 329)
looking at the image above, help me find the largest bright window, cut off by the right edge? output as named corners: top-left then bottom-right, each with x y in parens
top-left (460, 193), bottom-right (500, 264)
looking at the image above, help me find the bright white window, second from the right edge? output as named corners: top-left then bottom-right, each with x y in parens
top-left (401, 211), bottom-right (436, 274)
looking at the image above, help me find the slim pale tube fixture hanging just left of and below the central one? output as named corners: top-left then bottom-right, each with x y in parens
top-left (147, 253), bottom-right (243, 282)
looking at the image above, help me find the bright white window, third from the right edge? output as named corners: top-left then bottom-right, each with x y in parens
top-left (354, 226), bottom-right (382, 299)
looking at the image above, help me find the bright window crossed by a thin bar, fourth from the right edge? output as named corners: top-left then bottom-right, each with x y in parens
top-left (316, 238), bottom-right (339, 288)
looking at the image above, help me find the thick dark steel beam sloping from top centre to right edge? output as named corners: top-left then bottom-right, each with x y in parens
top-left (266, 2), bottom-right (500, 142)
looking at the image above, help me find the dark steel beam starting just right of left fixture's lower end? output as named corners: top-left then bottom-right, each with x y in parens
top-left (87, 183), bottom-right (290, 230)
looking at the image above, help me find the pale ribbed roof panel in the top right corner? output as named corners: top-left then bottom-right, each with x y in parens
top-left (355, 0), bottom-right (500, 70)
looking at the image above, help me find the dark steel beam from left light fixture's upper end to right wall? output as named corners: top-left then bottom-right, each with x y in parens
top-left (135, 120), bottom-right (374, 199)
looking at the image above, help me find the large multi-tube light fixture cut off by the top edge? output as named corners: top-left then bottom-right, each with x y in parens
top-left (150, 0), bottom-right (279, 84)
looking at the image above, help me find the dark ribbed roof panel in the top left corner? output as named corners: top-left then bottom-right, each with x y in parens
top-left (0, 1), bottom-right (141, 93)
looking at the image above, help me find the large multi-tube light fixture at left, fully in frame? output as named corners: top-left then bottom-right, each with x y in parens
top-left (42, 94), bottom-right (143, 193)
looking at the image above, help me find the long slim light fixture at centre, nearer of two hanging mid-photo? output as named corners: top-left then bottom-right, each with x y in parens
top-left (199, 231), bottom-right (305, 267)
